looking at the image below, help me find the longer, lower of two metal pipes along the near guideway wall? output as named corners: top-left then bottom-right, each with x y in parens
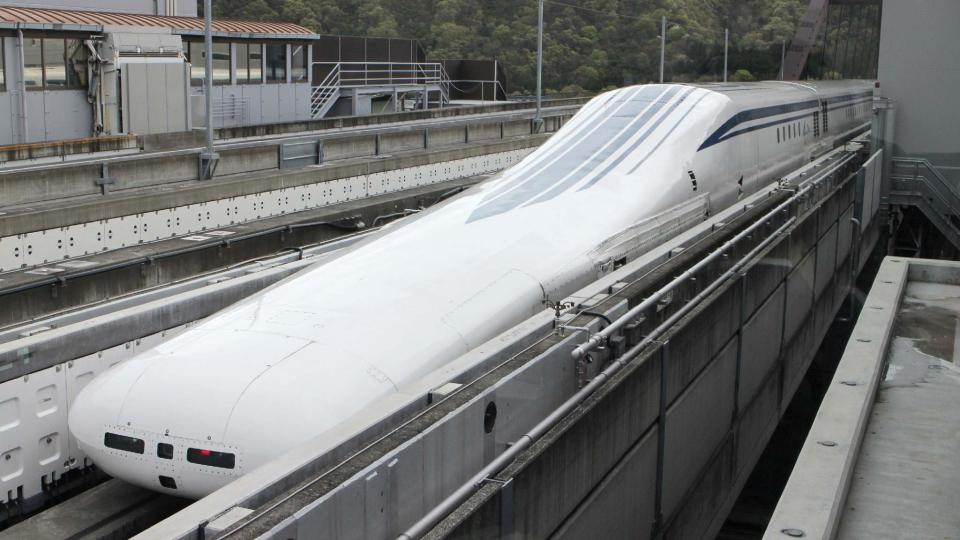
top-left (397, 217), bottom-right (797, 540)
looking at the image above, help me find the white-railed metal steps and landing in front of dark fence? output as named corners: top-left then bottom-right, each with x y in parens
top-left (310, 62), bottom-right (450, 120)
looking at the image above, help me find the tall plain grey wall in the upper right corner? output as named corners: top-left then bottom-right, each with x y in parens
top-left (878, 0), bottom-right (960, 171)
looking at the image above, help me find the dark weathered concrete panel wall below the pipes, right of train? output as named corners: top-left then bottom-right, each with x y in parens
top-left (430, 153), bottom-right (876, 538)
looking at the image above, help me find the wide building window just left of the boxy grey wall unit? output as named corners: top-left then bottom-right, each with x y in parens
top-left (23, 38), bottom-right (89, 90)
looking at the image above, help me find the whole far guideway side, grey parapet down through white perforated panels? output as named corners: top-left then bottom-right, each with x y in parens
top-left (0, 109), bottom-right (573, 279)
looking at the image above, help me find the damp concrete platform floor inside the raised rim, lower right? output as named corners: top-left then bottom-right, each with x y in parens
top-left (837, 278), bottom-right (960, 540)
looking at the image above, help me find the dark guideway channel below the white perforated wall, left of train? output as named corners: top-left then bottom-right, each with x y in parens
top-left (0, 175), bottom-right (488, 328)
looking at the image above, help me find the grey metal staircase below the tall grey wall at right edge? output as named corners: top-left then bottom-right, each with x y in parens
top-left (887, 157), bottom-right (960, 250)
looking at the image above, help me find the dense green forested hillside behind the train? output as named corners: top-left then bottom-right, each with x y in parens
top-left (213, 0), bottom-right (872, 94)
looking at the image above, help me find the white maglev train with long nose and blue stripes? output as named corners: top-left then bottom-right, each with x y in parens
top-left (69, 81), bottom-right (872, 498)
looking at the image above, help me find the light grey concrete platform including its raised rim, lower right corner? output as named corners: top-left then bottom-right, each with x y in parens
top-left (764, 257), bottom-right (960, 540)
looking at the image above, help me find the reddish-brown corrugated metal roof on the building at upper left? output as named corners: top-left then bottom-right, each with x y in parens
top-left (0, 7), bottom-right (313, 35)
